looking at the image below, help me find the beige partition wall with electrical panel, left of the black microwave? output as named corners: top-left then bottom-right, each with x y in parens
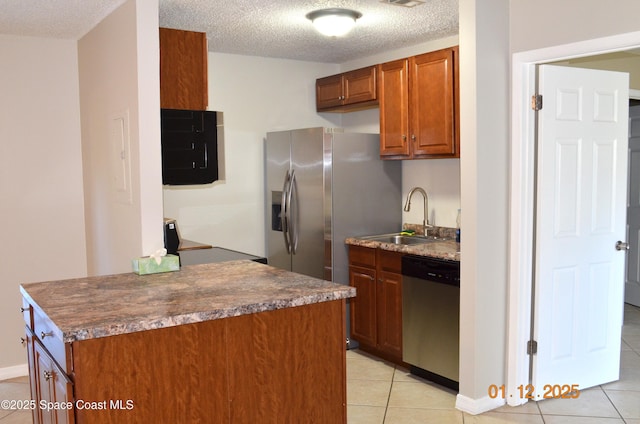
top-left (78, 0), bottom-right (164, 275)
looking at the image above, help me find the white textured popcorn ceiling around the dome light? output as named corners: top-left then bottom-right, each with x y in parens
top-left (0, 0), bottom-right (458, 63)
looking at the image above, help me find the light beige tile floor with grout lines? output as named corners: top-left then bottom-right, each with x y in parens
top-left (0, 305), bottom-right (640, 424)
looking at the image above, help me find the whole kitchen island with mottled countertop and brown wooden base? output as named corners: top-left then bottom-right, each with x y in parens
top-left (20, 261), bottom-right (355, 423)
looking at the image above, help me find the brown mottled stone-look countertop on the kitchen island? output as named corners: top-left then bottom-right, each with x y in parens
top-left (20, 260), bottom-right (356, 343)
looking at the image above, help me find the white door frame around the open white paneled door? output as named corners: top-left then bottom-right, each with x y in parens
top-left (506, 32), bottom-right (640, 406)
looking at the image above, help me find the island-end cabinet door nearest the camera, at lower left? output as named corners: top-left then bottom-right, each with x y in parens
top-left (33, 342), bottom-right (75, 424)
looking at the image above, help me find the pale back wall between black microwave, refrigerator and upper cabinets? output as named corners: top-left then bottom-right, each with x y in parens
top-left (164, 53), bottom-right (339, 255)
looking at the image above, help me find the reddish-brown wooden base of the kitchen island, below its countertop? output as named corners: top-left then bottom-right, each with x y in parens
top-left (27, 300), bottom-right (347, 424)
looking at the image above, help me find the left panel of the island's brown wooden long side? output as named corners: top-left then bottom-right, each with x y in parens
top-left (72, 320), bottom-right (229, 424)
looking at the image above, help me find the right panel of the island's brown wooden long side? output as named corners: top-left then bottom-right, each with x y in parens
top-left (227, 300), bottom-right (347, 424)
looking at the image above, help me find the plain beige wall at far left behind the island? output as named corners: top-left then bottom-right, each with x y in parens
top-left (0, 35), bottom-right (87, 372)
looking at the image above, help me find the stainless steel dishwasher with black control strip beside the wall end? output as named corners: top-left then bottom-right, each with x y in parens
top-left (402, 255), bottom-right (460, 391)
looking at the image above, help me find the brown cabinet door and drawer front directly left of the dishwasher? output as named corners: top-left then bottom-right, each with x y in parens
top-left (376, 250), bottom-right (402, 361)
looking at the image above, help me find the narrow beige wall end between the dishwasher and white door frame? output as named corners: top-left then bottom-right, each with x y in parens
top-left (457, 0), bottom-right (509, 412)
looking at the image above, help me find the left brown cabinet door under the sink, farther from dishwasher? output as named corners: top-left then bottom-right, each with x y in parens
top-left (349, 266), bottom-right (377, 347)
